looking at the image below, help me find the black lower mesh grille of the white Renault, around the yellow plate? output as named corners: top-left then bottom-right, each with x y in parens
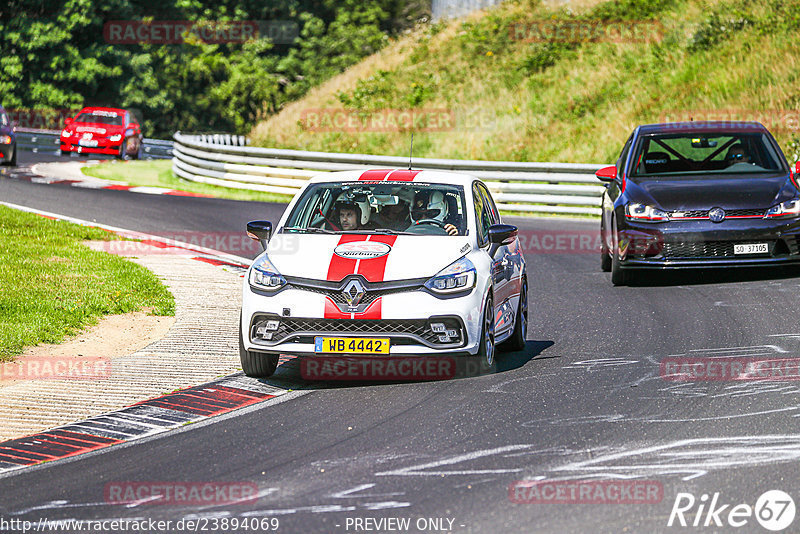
top-left (251, 316), bottom-right (465, 348)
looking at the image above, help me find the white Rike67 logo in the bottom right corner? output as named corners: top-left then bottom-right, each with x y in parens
top-left (667, 490), bottom-right (795, 532)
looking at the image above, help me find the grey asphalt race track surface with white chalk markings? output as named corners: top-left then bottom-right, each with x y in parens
top-left (0, 153), bottom-right (800, 533)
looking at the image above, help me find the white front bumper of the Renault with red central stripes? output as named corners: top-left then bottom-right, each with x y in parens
top-left (241, 280), bottom-right (483, 355)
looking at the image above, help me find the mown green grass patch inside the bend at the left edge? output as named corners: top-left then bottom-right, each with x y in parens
top-left (0, 206), bottom-right (175, 361)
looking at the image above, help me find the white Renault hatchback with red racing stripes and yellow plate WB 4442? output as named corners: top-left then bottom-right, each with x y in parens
top-left (239, 169), bottom-right (528, 377)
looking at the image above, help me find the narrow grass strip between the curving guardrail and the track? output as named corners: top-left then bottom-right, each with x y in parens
top-left (82, 160), bottom-right (292, 203)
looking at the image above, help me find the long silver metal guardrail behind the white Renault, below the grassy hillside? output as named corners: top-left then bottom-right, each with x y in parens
top-left (172, 132), bottom-right (604, 215)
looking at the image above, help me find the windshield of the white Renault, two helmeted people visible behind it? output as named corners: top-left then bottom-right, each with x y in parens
top-left (284, 182), bottom-right (467, 235)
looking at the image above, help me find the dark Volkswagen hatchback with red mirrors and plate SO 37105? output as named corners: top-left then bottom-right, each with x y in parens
top-left (597, 122), bottom-right (800, 285)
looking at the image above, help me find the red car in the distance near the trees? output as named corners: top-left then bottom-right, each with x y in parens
top-left (61, 107), bottom-right (142, 159)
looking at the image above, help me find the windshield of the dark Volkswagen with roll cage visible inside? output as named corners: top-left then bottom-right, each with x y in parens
top-left (631, 132), bottom-right (784, 177)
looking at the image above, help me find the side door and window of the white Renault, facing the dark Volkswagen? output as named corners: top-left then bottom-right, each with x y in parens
top-left (472, 182), bottom-right (519, 333)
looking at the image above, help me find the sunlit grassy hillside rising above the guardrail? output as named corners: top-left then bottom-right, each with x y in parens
top-left (251, 0), bottom-right (800, 162)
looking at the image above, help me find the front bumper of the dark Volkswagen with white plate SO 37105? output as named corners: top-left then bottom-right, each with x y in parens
top-left (616, 218), bottom-right (800, 269)
